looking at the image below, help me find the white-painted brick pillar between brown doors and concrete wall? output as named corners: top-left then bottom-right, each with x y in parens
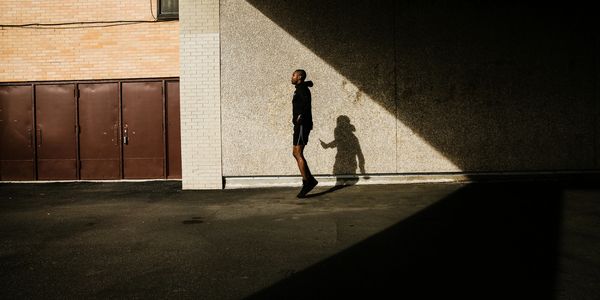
top-left (179, 0), bottom-right (223, 189)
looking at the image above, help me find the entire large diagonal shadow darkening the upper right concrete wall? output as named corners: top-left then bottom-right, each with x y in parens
top-left (247, 0), bottom-right (599, 172)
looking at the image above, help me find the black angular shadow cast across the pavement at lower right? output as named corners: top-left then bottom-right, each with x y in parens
top-left (249, 182), bottom-right (563, 299)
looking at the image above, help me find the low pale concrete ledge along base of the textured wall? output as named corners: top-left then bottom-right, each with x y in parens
top-left (224, 170), bottom-right (600, 189)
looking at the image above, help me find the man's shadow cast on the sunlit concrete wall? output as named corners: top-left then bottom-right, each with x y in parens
top-left (308, 115), bottom-right (366, 197)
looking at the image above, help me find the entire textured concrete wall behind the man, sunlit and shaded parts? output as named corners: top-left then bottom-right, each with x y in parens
top-left (221, 0), bottom-right (598, 176)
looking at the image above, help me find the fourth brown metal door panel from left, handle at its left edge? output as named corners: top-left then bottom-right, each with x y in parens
top-left (122, 81), bottom-right (165, 179)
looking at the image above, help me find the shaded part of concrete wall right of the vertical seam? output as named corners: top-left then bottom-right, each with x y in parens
top-left (395, 1), bottom-right (599, 171)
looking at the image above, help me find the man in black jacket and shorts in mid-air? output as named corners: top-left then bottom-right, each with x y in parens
top-left (292, 70), bottom-right (319, 198)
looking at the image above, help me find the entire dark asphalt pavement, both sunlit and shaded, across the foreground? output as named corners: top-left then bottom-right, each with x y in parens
top-left (0, 179), bottom-right (600, 299)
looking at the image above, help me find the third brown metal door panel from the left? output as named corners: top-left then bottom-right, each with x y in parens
top-left (79, 83), bottom-right (121, 179)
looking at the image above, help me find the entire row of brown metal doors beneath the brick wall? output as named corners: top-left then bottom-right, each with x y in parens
top-left (0, 78), bottom-right (181, 181)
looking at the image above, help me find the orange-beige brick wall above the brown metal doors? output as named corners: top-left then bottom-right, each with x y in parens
top-left (0, 0), bottom-right (179, 82)
